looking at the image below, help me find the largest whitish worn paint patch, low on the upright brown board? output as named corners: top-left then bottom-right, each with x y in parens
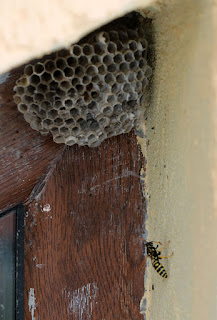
top-left (62, 283), bottom-right (99, 320)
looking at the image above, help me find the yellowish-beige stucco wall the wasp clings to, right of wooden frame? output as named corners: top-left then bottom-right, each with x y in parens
top-left (141, 0), bottom-right (217, 320)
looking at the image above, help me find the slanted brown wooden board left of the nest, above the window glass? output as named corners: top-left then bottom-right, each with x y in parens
top-left (0, 66), bottom-right (63, 212)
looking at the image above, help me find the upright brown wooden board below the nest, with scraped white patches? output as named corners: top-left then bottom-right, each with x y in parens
top-left (25, 133), bottom-right (145, 320)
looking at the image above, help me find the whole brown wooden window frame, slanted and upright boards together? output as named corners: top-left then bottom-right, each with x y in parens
top-left (0, 18), bottom-right (149, 320)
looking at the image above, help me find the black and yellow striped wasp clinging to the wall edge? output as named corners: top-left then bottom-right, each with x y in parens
top-left (139, 238), bottom-right (173, 278)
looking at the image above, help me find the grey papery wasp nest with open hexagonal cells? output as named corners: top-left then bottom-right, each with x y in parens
top-left (14, 27), bottom-right (151, 147)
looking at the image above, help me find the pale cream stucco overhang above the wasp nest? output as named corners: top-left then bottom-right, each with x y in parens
top-left (0, 0), bottom-right (156, 73)
